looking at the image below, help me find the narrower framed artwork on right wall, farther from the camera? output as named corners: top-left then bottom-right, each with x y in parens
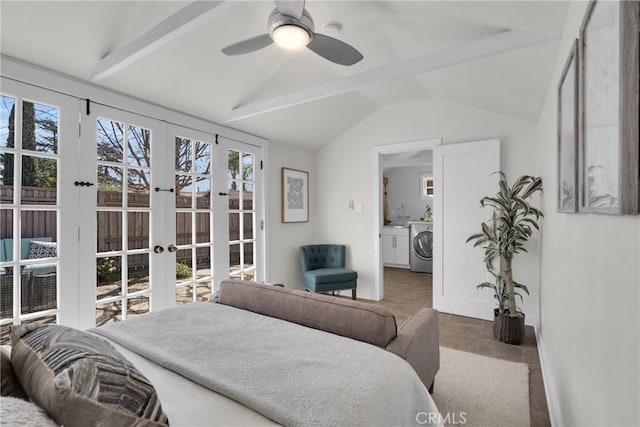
top-left (557, 39), bottom-right (579, 213)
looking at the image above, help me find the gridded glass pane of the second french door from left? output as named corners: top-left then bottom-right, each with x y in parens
top-left (95, 115), bottom-right (154, 326)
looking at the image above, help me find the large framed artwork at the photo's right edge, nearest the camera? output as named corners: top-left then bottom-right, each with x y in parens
top-left (579, 0), bottom-right (640, 215)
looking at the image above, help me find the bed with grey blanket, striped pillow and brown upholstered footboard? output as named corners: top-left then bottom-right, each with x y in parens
top-left (2, 281), bottom-right (439, 426)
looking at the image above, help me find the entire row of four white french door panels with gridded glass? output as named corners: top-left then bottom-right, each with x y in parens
top-left (0, 78), bottom-right (264, 336)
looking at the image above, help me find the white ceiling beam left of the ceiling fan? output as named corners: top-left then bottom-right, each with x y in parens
top-left (91, 0), bottom-right (238, 82)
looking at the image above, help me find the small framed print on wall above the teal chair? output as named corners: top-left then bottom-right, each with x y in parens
top-left (281, 168), bottom-right (309, 222)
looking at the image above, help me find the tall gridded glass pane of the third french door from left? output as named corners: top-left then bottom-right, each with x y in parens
top-left (174, 134), bottom-right (215, 304)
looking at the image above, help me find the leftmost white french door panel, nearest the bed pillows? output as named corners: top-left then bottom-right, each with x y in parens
top-left (0, 78), bottom-right (78, 344)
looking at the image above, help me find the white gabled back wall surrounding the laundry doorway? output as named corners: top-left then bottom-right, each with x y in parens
top-left (315, 99), bottom-right (539, 310)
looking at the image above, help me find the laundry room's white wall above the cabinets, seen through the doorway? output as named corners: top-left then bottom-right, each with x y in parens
top-left (384, 165), bottom-right (433, 224)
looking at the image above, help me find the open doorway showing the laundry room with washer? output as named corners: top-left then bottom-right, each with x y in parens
top-left (372, 139), bottom-right (442, 306)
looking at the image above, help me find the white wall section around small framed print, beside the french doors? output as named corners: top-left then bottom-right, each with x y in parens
top-left (267, 142), bottom-right (316, 289)
